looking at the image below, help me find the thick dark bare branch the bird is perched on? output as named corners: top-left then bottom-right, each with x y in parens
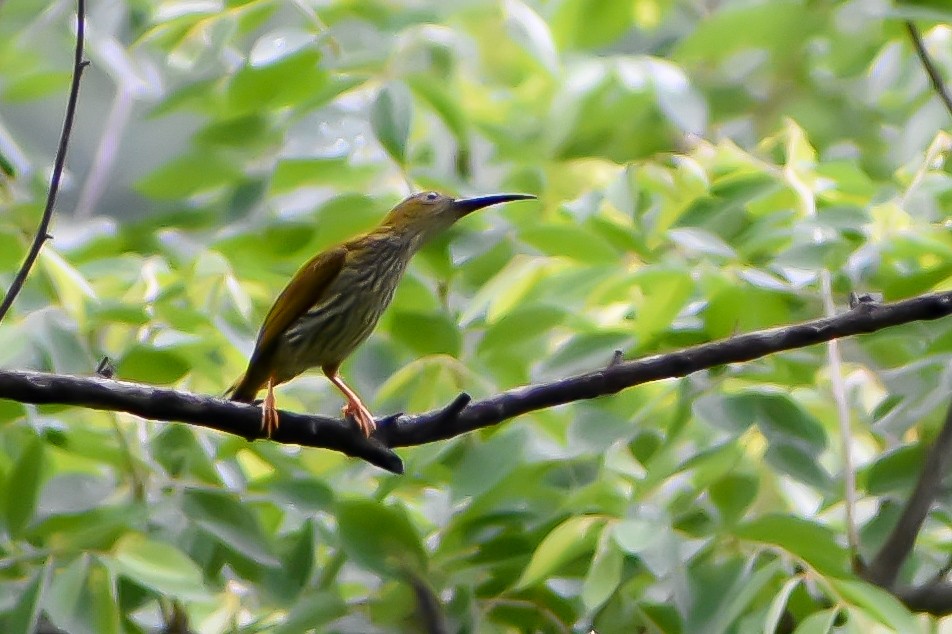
top-left (0, 292), bottom-right (952, 473)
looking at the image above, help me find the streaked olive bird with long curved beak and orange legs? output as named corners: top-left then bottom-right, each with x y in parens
top-left (225, 191), bottom-right (535, 438)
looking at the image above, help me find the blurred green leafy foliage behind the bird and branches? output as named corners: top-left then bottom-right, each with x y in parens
top-left (0, 0), bottom-right (952, 633)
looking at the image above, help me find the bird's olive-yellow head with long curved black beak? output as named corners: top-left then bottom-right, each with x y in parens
top-left (383, 192), bottom-right (535, 241)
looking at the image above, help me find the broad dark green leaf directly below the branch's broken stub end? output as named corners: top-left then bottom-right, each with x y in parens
top-left (337, 499), bottom-right (427, 576)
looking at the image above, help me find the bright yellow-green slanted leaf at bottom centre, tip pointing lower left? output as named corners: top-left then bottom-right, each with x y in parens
top-left (514, 515), bottom-right (605, 590)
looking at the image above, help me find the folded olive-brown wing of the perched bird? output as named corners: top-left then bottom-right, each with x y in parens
top-left (226, 245), bottom-right (347, 402)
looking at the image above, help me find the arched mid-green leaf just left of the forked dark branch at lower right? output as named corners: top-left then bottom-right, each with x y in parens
top-left (733, 514), bottom-right (849, 575)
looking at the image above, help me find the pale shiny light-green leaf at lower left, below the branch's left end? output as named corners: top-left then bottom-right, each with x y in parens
top-left (105, 533), bottom-right (206, 599)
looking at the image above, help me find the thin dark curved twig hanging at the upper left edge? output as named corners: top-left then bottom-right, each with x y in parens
top-left (0, 0), bottom-right (89, 321)
